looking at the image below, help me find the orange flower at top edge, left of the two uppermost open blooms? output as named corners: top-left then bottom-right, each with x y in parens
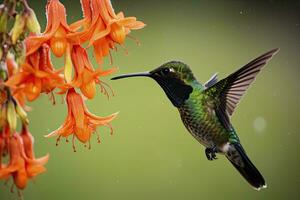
top-left (26, 0), bottom-right (72, 57)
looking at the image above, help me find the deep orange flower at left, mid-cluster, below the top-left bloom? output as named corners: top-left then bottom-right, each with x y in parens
top-left (5, 44), bottom-right (63, 102)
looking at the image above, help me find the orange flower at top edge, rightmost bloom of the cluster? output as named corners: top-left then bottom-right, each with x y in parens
top-left (68, 0), bottom-right (145, 64)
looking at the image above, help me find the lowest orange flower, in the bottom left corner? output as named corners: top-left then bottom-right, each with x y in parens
top-left (0, 133), bottom-right (48, 190)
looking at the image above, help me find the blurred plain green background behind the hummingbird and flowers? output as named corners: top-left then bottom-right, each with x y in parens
top-left (0, 0), bottom-right (300, 200)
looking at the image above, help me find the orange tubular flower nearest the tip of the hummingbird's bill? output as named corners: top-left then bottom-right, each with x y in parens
top-left (60, 45), bottom-right (116, 99)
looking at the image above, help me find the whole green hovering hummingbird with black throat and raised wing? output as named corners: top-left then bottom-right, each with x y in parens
top-left (112, 49), bottom-right (279, 190)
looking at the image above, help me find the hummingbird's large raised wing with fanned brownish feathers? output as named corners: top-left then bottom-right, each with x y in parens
top-left (204, 49), bottom-right (278, 130)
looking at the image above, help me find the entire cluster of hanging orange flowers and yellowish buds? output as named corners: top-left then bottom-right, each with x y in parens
top-left (0, 0), bottom-right (145, 193)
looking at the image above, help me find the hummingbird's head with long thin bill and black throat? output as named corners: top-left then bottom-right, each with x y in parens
top-left (112, 61), bottom-right (196, 107)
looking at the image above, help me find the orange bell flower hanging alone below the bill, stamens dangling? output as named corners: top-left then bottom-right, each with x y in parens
top-left (45, 88), bottom-right (117, 151)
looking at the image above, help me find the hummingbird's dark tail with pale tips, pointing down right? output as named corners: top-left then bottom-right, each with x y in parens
top-left (225, 143), bottom-right (267, 190)
